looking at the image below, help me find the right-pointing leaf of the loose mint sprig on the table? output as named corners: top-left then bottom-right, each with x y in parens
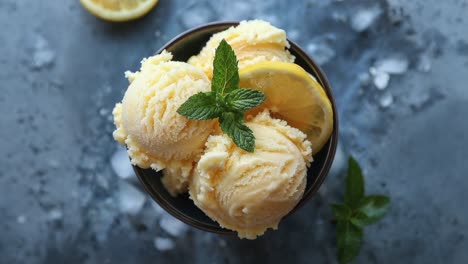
top-left (351, 195), bottom-right (390, 227)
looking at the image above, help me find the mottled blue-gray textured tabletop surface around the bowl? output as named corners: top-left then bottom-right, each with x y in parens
top-left (0, 0), bottom-right (468, 263)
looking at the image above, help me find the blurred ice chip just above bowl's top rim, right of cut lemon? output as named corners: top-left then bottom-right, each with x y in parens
top-left (179, 1), bottom-right (216, 28)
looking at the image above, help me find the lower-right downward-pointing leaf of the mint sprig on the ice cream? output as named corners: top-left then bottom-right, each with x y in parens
top-left (219, 112), bottom-right (255, 152)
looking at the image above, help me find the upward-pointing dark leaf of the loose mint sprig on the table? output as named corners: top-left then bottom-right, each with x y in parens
top-left (344, 157), bottom-right (364, 209)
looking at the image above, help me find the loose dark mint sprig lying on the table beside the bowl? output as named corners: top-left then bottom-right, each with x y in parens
top-left (331, 157), bottom-right (390, 264)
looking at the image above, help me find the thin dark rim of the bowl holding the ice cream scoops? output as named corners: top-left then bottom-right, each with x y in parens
top-left (133, 21), bottom-right (339, 235)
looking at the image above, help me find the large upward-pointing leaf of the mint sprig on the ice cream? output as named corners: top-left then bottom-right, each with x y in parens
top-left (211, 39), bottom-right (239, 95)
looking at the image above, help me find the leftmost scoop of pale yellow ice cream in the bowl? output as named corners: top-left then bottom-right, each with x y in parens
top-left (113, 51), bottom-right (216, 195)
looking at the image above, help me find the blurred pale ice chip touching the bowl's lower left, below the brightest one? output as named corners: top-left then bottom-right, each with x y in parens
top-left (118, 181), bottom-right (146, 215)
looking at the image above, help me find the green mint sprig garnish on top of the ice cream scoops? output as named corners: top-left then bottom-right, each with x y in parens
top-left (177, 39), bottom-right (266, 152)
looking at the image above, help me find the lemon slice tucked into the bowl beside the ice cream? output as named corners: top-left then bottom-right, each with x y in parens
top-left (239, 62), bottom-right (333, 154)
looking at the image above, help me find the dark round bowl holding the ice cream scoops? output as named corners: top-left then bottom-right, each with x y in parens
top-left (134, 22), bottom-right (338, 234)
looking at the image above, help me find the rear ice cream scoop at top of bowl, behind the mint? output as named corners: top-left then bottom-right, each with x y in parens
top-left (188, 20), bottom-right (294, 79)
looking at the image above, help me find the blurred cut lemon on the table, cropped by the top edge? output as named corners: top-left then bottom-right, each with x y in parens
top-left (80, 0), bottom-right (159, 22)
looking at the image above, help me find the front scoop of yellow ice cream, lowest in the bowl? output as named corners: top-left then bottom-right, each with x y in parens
top-left (190, 112), bottom-right (312, 239)
